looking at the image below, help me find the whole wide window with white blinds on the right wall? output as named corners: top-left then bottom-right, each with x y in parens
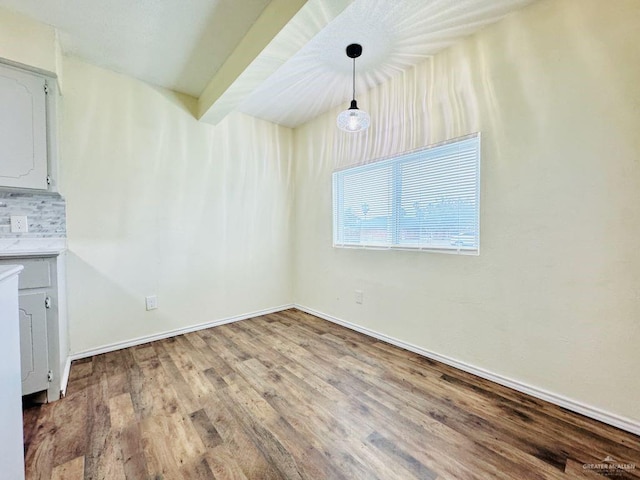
top-left (333, 133), bottom-right (480, 255)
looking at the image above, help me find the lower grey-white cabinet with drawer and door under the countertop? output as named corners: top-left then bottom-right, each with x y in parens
top-left (0, 254), bottom-right (69, 402)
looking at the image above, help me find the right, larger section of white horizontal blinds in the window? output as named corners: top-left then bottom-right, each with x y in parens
top-left (397, 137), bottom-right (479, 251)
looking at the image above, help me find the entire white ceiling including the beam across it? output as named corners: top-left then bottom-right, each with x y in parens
top-left (0, 0), bottom-right (534, 127)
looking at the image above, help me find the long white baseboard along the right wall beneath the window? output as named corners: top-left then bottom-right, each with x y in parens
top-left (295, 305), bottom-right (640, 435)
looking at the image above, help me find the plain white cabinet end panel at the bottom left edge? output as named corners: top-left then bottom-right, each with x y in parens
top-left (0, 265), bottom-right (24, 480)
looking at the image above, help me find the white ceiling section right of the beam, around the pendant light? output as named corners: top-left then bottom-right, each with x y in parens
top-left (239, 0), bottom-right (533, 127)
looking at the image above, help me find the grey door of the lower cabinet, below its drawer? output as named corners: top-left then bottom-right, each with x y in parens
top-left (19, 293), bottom-right (49, 395)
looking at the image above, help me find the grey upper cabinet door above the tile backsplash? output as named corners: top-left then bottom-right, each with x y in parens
top-left (0, 65), bottom-right (47, 190)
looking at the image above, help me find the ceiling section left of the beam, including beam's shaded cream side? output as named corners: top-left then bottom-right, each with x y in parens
top-left (0, 0), bottom-right (270, 97)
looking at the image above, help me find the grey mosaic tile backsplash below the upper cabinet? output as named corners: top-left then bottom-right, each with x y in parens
top-left (0, 191), bottom-right (67, 238)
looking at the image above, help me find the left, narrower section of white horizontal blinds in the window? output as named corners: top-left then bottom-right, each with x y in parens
top-left (334, 163), bottom-right (393, 247)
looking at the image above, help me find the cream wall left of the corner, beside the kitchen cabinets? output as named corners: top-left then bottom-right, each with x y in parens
top-left (60, 58), bottom-right (292, 353)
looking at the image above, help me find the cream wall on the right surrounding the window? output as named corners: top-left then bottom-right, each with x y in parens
top-left (294, 0), bottom-right (640, 422)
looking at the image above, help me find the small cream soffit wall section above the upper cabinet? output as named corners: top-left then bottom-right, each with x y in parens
top-left (0, 8), bottom-right (57, 73)
